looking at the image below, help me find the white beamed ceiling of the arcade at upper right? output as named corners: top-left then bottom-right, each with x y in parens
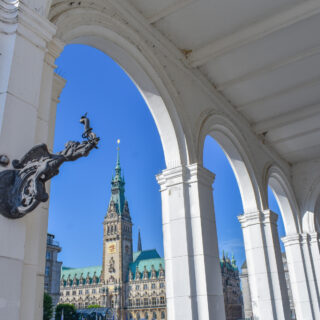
top-left (127, 0), bottom-right (320, 163)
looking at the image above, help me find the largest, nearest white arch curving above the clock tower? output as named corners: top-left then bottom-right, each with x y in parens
top-left (53, 8), bottom-right (192, 168)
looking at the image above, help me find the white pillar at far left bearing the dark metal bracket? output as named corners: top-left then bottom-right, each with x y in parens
top-left (0, 0), bottom-right (55, 320)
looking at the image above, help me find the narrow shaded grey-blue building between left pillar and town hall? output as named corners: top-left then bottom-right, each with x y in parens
top-left (44, 233), bottom-right (62, 306)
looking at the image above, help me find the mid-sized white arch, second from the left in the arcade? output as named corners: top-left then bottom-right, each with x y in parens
top-left (198, 114), bottom-right (266, 213)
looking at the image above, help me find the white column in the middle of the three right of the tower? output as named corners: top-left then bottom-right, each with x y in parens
top-left (238, 210), bottom-right (290, 320)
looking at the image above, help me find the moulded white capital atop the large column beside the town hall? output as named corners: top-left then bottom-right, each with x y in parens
top-left (156, 163), bottom-right (215, 191)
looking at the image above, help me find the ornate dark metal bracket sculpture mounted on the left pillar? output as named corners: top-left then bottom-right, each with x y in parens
top-left (0, 114), bottom-right (100, 219)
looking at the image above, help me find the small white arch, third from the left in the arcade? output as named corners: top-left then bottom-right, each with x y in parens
top-left (265, 165), bottom-right (301, 235)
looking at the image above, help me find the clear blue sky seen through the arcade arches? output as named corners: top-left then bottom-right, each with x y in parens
top-left (48, 45), bottom-right (284, 267)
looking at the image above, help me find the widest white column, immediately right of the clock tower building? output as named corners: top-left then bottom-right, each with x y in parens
top-left (157, 164), bottom-right (225, 320)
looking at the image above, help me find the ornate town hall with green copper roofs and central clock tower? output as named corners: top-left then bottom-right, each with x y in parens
top-left (59, 153), bottom-right (242, 320)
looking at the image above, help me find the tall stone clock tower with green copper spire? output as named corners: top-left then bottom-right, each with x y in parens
top-left (101, 140), bottom-right (133, 319)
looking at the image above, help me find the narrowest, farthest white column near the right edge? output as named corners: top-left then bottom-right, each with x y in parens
top-left (281, 234), bottom-right (315, 320)
